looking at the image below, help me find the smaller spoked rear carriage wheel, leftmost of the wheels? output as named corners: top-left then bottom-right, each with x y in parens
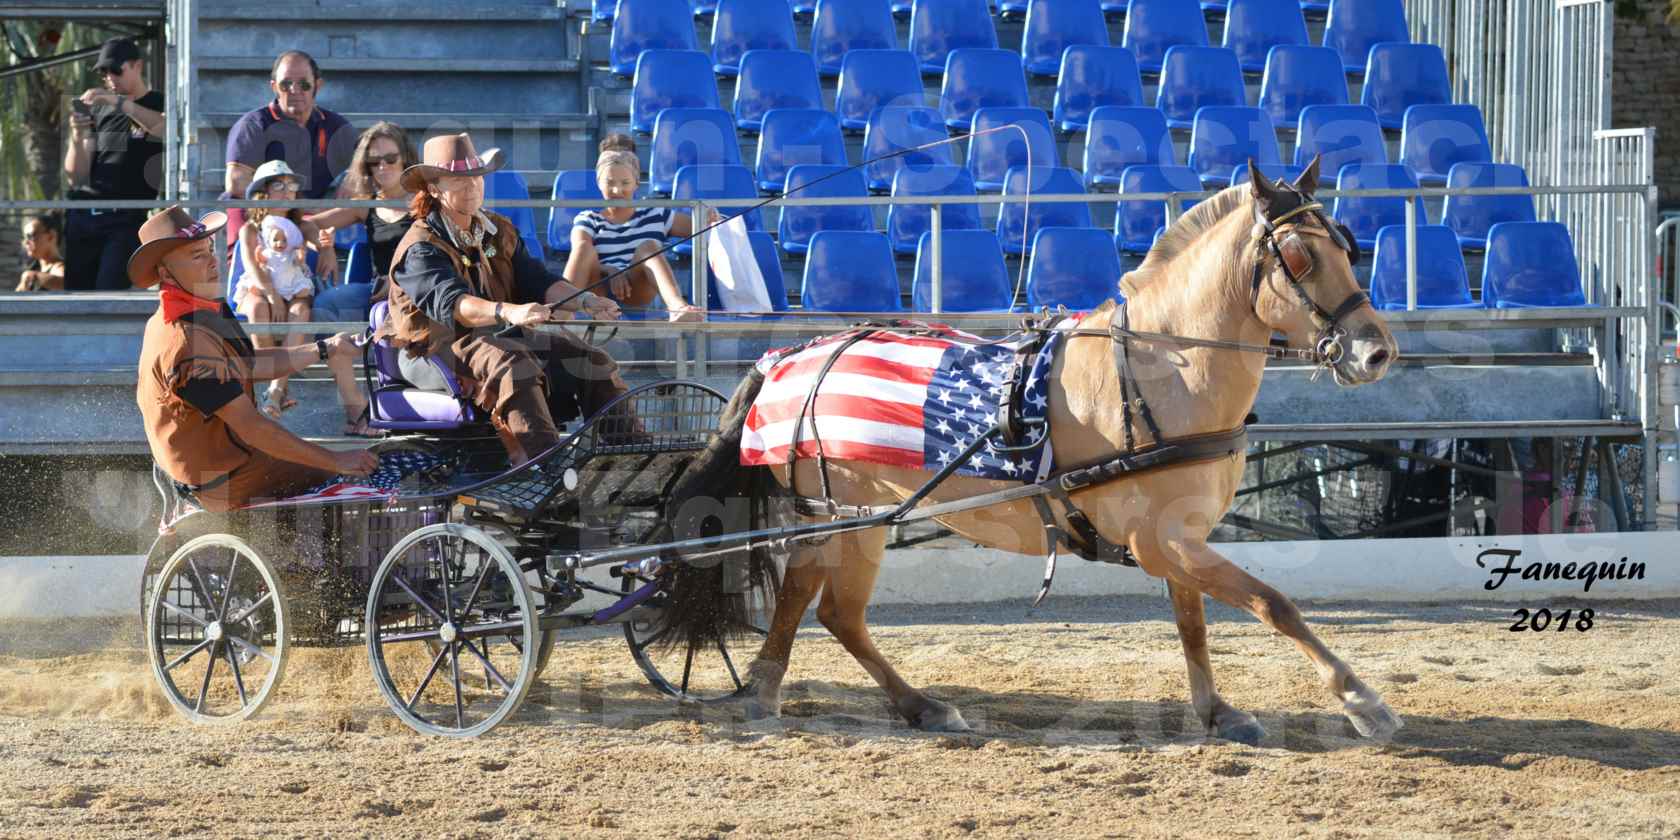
top-left (146, 534), bottom-right (291, 722)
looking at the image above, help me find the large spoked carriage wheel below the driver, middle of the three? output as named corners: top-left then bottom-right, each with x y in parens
top-left (365, 522), bottom-right (543, 738)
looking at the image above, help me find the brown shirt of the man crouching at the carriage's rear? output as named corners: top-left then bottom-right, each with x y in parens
top-left (134, 304), bottom-right (255, 487)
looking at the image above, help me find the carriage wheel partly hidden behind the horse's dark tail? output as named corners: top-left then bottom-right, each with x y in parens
top-left (622, 576), bottom-right (769, 704)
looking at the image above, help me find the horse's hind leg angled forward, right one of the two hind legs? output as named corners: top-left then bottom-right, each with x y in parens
top-left (816, 528), bottom-right (969, 732)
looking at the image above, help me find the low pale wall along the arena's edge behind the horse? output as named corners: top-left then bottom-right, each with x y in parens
top-left (0, 533), bottom-right (1680, 622)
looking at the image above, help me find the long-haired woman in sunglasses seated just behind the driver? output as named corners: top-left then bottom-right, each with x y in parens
top-left (309, 123), bottom-right (420, 321)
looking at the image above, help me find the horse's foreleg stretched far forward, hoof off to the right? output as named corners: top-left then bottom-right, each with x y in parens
top-left (1132, 538), bottom-right (1403, 738)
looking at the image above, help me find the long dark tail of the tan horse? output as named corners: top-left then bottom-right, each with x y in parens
top-left (659, 370), bottom-right (781, 650)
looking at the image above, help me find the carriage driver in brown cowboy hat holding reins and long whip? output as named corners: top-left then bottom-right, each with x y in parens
top-left (378, 134), bottom-right (627, 462)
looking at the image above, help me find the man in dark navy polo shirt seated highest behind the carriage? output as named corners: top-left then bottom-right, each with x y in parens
top-left (225, 50), bottom-right (356, 198)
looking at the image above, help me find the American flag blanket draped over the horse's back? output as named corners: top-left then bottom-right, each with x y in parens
top-left (741, 319), bottom-right (1075, 482)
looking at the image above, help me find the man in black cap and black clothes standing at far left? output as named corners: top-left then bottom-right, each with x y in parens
top-left (64, 39), bottom-right (165, 291)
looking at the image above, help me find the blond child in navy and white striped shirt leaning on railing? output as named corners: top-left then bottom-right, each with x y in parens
top-left (566, 142), bottom-right (704, 321)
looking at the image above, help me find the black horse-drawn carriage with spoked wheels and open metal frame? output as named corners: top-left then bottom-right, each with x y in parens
top-left (141, 380), bottom-right (769, 736)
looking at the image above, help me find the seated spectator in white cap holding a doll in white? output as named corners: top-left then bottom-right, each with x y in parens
top-left (228, 160), bottom-right (351, 426)
